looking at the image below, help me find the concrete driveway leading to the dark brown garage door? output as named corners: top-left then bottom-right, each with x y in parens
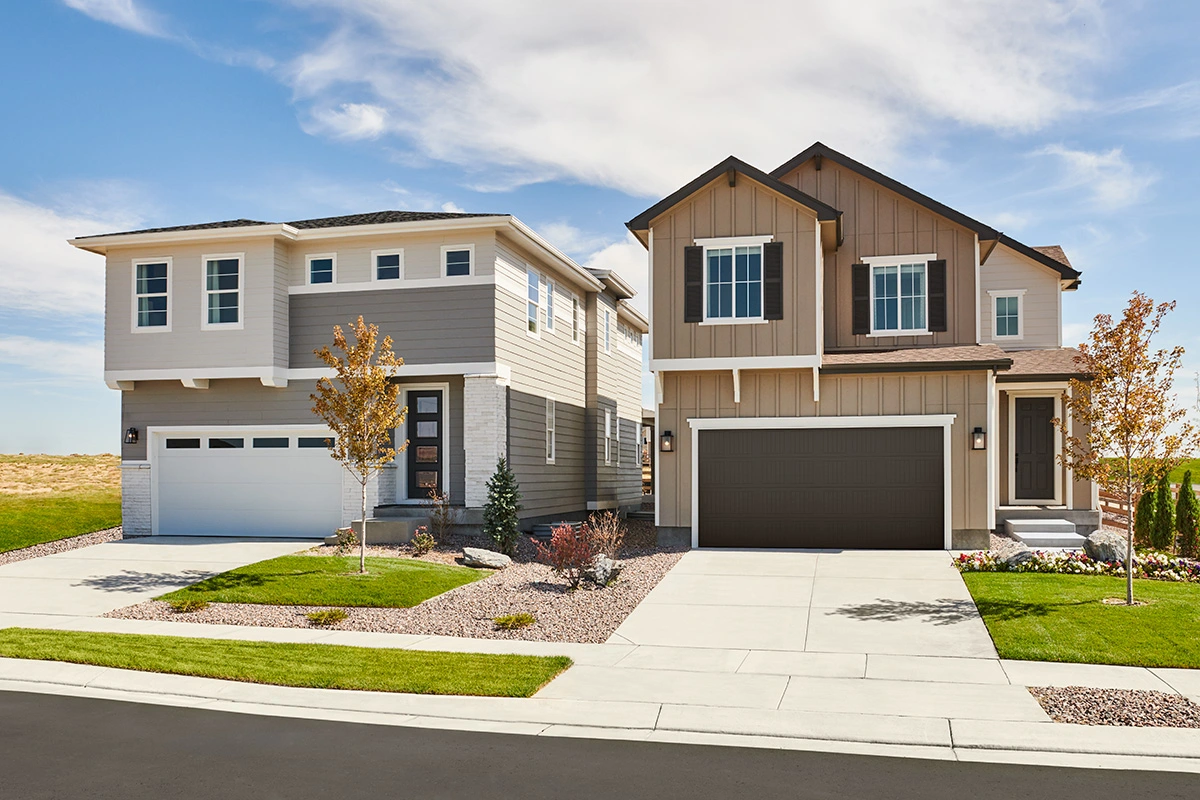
top-left (610, 551), bottom-right (997, 664)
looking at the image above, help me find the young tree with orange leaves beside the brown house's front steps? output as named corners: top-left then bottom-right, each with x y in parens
top-left (1055, 291), bottom-right (1196, 604)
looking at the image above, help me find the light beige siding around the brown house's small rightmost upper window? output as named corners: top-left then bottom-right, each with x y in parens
top-left (979, 245), bottom-right (1062, 350)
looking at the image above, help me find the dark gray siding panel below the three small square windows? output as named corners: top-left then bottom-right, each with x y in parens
top-left (289, 284), bottom-right (496, 368)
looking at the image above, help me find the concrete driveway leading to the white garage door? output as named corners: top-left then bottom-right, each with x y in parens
top-left (0, 536), bottom-right (316, 625)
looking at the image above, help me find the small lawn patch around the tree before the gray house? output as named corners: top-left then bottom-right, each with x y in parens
top-left (158, 555), bottom-right (488, 608)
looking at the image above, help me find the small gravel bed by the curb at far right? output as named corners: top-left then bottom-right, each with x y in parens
top-left (1028, 686), bottom-right (1200, 728)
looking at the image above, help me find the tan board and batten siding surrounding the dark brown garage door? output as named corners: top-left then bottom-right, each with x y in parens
top-left (655, 369), bottom-right (989, 530)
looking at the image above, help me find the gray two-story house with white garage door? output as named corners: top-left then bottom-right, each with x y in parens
top-left (71, 211), bottom-right (648, 536)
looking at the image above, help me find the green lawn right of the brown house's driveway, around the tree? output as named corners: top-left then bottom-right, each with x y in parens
top-left (962, 572), bottom-right (1200, 668)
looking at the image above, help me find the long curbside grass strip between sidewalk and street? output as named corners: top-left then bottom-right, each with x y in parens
top-left (0, 627), bottom-right (571, 697)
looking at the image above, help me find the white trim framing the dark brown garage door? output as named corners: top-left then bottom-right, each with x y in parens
top-left (688, 414), bottom-right (958, 549)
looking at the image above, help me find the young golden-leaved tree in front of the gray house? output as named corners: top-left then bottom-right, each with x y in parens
top-left (310, 317), bottom-right (408, 573)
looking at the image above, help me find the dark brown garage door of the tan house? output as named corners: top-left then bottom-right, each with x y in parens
top-left (698, 428), bottom-right (944, 549)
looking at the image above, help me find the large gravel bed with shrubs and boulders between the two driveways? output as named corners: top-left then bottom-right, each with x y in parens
top-left (104, 531), bottom-right (684, 643)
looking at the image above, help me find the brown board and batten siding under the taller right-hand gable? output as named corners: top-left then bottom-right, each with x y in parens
top-left (780, 158), bottom-right (978, 350)
